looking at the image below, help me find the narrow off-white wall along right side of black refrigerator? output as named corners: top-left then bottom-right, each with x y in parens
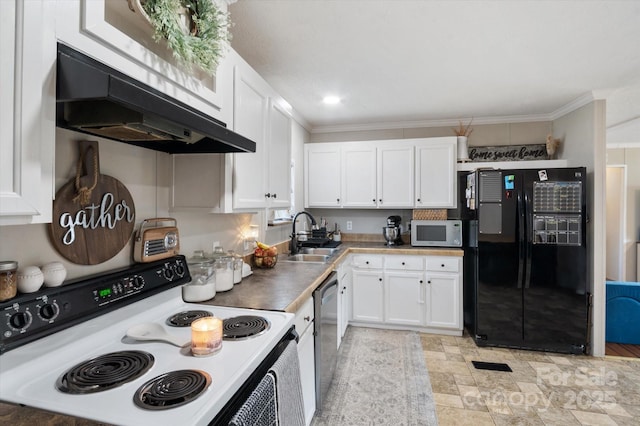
top-left (553, 100), bottom-right (606, 356)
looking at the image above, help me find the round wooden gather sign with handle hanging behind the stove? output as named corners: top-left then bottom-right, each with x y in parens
top-left (50, 141), bottom-right (136, 265)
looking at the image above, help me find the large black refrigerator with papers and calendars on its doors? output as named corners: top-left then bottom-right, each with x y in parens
top-left (450, 167), bottom-right (590, 353)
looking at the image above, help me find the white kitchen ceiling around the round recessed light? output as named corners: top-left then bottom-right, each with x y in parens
top-left (229, 0), bottom-right (640, 131)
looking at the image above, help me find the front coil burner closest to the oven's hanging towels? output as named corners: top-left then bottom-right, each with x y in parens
top-left (133, 370), bottom-right (211, 410)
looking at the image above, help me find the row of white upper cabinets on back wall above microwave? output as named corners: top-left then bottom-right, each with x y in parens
top-left (305, 137), bottom-right (456, 209)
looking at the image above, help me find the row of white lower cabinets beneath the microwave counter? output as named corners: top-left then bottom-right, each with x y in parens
top-left (351, 254), bottom-right (462, 335)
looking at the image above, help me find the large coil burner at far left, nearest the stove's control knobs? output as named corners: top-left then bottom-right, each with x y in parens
top-left (56, 351), bottom-right (155, 394)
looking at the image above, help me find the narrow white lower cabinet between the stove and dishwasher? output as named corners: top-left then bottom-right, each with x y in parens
top-left (294, 297), bottom-right (316, 425)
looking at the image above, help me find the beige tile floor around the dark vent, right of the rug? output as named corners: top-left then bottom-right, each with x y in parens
top-left (421, 334), bottom-right (640, 426)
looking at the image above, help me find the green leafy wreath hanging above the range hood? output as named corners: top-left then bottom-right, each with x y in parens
top-left (140, 0), bottom-right (231, 75)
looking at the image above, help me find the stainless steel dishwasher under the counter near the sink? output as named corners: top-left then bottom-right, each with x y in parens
top-left (313, 272), bottom-right (338, 411)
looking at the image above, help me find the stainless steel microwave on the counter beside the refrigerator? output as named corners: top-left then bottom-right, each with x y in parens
top-left (411, 220), bottom-right (462, 247)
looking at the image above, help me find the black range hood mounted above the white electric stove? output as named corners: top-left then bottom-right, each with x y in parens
top-left (56, 43), bottom-right (256, 154)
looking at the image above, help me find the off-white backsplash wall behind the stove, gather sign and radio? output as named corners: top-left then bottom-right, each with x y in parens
top-left (0, 129), bottom-right (251, 278)
